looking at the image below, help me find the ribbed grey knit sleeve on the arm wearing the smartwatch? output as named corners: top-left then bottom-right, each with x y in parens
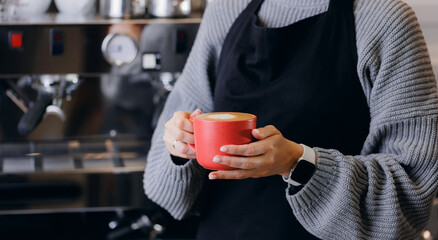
top-left (286, 1), bottom-right (438, 240)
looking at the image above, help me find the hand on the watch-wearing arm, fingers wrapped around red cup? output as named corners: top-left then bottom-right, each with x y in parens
top-left (208, 125), bottom-right (303, 180)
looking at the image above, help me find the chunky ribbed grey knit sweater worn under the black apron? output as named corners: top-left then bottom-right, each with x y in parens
top-left (144, 0), bottom-right (438, 240)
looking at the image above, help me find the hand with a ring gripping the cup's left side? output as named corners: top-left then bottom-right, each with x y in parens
top-left (163, 109), bottom-right (201, 159)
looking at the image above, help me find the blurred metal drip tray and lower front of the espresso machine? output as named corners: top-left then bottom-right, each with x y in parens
top-left (0, 139), bottom-right (149, 215)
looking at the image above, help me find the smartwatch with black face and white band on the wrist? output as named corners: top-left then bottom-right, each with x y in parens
top-left (283, 144), bottom-right (316, 187)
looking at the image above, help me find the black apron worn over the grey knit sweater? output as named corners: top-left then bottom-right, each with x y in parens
top-left (197, 0), bottom-right (370, 237)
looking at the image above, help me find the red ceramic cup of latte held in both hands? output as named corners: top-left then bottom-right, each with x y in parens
top-left (189, 112), bottom-right (257, 170)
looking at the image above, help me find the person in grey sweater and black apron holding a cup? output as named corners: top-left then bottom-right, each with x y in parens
top-left (144, 0), bottom-right (438, 240)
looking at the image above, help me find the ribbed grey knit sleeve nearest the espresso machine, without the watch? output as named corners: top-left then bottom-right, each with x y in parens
top-left (143, 3), bottom-right (219, 219)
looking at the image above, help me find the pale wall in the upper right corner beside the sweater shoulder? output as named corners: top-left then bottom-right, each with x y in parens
top-left (404, 0), bottom-right (438, 76)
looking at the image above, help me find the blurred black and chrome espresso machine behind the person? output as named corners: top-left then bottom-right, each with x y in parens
top-left (0, 14), bottom-right (200, 239)
